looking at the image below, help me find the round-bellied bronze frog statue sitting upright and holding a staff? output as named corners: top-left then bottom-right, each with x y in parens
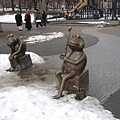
top-left (53, 28), bottom-right (87, 99)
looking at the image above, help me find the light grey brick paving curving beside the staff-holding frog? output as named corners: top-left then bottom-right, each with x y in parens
top-left (82, 28), bottom-right (120, 103)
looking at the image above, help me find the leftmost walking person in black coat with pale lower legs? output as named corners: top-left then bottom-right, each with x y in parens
top-left (15, 11), bottom-right (22, 31)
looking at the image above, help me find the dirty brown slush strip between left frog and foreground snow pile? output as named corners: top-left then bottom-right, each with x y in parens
top-left (0, 65), bottom-right (57, 91)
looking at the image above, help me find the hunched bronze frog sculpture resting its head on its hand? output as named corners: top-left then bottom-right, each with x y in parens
top-left (7, 34), bottom-right (26, 71)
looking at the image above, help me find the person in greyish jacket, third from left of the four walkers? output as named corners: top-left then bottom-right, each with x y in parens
top-left (34, 10), bottom-right (43, 28)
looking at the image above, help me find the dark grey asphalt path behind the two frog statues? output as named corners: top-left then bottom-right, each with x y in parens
top-left (0, 24), bottom-right (98, 56)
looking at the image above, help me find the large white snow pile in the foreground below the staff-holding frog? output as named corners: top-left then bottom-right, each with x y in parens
top-left (0, 86), bottom-right (118, 120)
